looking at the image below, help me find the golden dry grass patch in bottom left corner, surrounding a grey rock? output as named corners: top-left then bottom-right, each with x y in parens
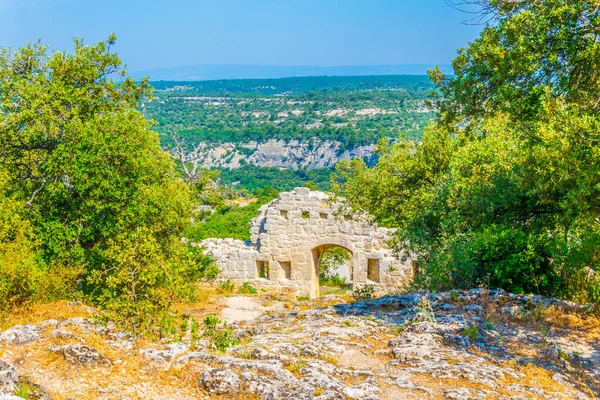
top-left (0, 318), bottom-right (199, 400)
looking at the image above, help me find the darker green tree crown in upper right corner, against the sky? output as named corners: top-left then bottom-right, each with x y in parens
top-left (430, 0), bottom-right (600, 127)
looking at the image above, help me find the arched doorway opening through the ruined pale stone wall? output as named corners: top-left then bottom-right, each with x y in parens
top-left (312, 243), bottom-right (354, 296)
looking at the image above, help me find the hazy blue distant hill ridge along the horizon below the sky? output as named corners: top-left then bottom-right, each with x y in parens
top-left (131, 64), bottom-right (452, 81)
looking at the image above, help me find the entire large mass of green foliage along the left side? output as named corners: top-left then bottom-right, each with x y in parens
top-left (0, 35), bottom-right (210, 333)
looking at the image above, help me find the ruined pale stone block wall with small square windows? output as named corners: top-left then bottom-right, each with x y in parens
top-left (202, 188), bottom-right (412, 297)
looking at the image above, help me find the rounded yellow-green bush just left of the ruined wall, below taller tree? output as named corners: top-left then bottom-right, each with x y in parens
top-left (86, 228), bottom-right (213, 337)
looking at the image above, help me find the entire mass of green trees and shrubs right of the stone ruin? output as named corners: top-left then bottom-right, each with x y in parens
top-left (337, 0), bottom-right (600, 301)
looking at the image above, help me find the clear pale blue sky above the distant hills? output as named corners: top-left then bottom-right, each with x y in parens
top-left (0, 0), bottom-right (482, 71)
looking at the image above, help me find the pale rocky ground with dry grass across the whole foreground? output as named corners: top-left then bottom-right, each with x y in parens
top-left (0, 289), bottom-right (600, 400)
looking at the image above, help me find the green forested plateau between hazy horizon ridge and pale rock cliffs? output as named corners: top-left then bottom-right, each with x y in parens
top-left (142, 76), bottom-right (433, 148)
